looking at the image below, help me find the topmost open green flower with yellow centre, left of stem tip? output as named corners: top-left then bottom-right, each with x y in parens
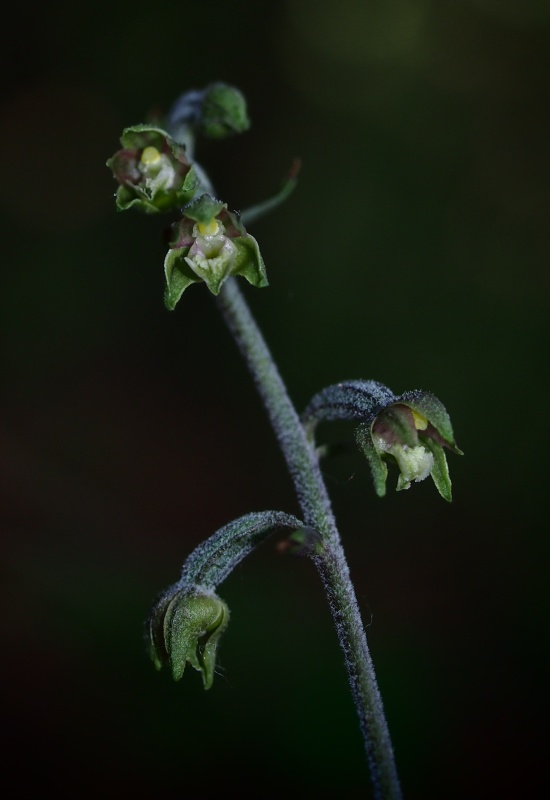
top-left (107, 125), bottom-right (199, 213)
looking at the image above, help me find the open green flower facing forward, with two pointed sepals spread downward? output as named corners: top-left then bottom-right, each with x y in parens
top-left (164, 194), bottom-right (268, 311)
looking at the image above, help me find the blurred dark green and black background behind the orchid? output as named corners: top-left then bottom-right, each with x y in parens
top-left (0, 0), bottom-right (550, 799)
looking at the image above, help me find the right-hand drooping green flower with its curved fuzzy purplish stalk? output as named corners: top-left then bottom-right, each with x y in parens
top-left (302, 381), bottom-right (462, 502)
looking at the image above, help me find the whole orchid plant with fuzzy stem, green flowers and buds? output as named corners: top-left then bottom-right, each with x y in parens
top-left (107, 83), bottom-right (461, 800)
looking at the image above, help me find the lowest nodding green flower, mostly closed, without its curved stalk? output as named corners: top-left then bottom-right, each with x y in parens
top-left (148, 587), bottom-right (229, 689)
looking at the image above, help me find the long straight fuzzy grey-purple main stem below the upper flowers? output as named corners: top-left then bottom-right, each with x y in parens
top-left (217, 278), bottom-right (402, 800)
